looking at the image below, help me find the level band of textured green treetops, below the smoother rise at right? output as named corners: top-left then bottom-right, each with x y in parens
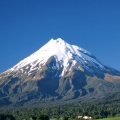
top-left (1, 102), bottom-right (120, 120)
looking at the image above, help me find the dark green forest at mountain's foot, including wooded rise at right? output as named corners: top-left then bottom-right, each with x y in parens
top-left (0, 92), bottom-right (120, 120)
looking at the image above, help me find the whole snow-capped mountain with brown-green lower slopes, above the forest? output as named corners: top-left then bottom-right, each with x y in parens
top-left (0, 38), bottom-right (120, 106)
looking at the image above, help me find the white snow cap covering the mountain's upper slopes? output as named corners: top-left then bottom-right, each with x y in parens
top-left (6, 38), bottom-right (109, 75)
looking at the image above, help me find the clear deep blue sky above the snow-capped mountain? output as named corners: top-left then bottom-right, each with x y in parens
top-left (0, 0), bottom-right (120, 72)
